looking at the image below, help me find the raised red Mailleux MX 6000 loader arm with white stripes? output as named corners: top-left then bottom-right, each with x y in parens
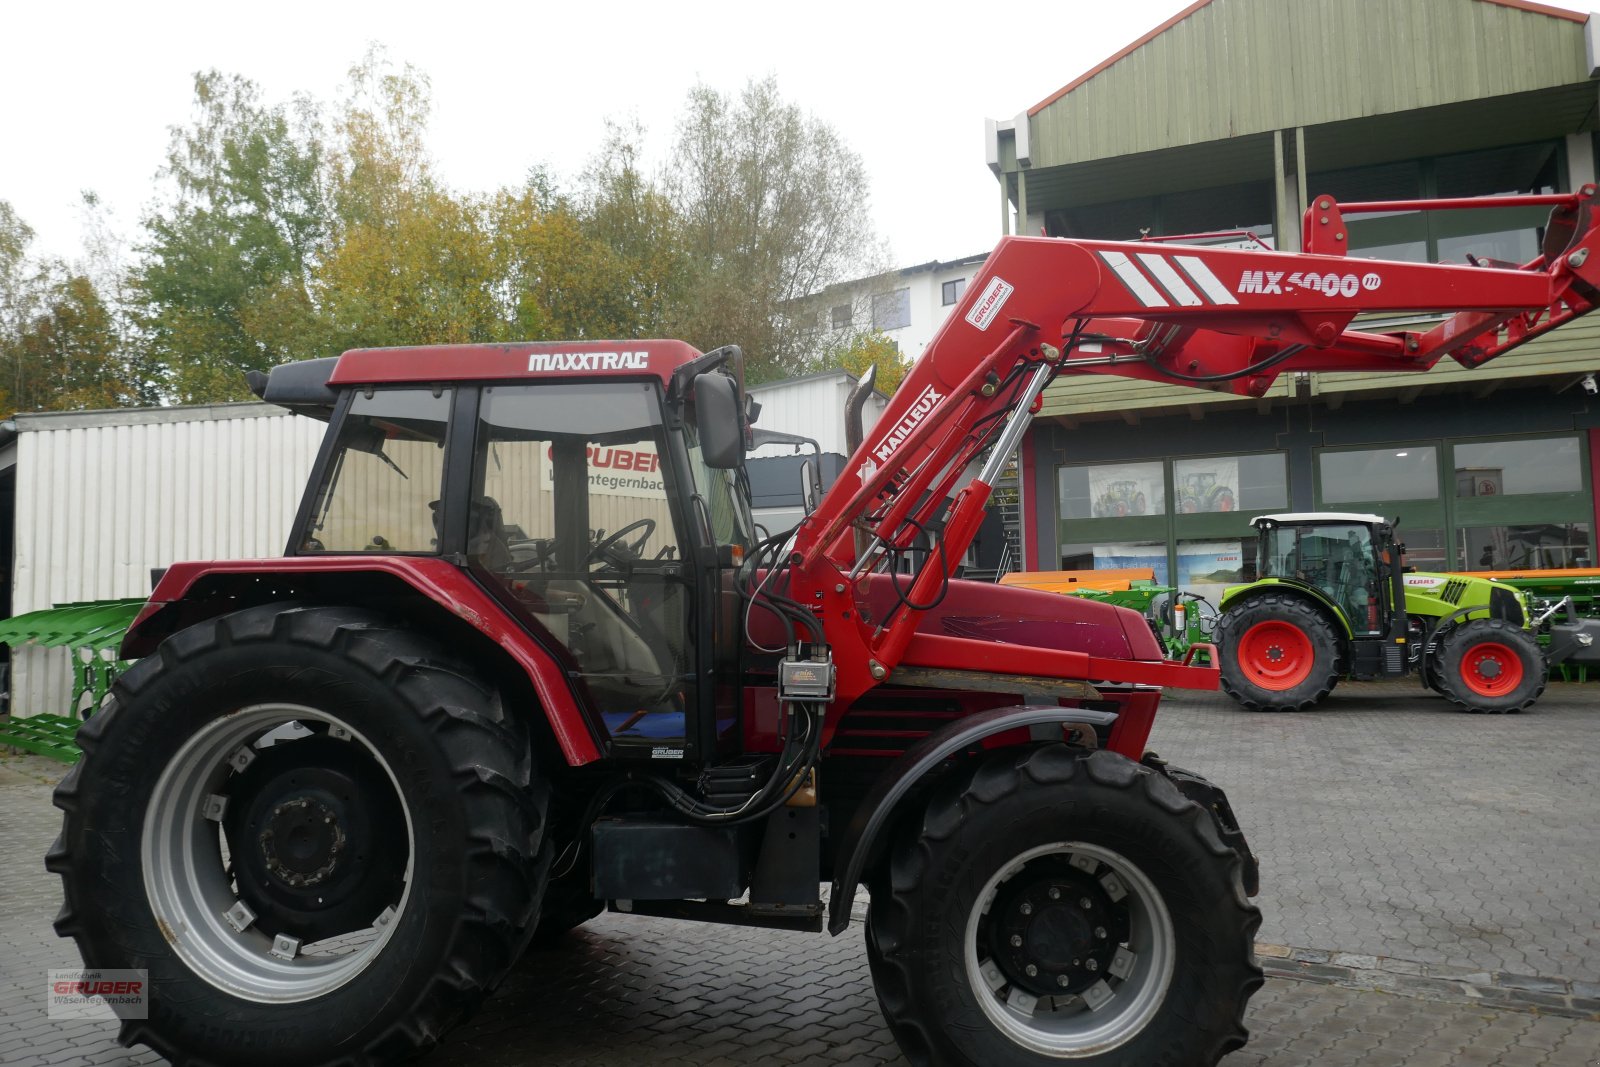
top-left (789, 186), bottom-right (1600, 716)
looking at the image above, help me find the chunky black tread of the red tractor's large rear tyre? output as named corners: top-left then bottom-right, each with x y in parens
top-left (46, 603), bottom-right (550, 1067)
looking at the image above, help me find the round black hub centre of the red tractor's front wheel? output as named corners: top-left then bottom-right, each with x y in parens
top-left (990, 859), bottom-right (1128, 997)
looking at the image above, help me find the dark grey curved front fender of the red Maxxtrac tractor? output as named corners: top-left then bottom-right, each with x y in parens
top-left (827, 704), bottom-right (1117, 936)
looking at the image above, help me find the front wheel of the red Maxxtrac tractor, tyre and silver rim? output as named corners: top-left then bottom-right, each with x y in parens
top-left (867, 744), bottom-right (1261, 1067)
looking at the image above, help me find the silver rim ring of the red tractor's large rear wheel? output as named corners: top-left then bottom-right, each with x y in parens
top-left (141, 704), bottom-right (416, 1003)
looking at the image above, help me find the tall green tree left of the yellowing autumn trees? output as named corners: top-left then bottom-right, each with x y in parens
top-left (131, 70), bottom-right (330, 403)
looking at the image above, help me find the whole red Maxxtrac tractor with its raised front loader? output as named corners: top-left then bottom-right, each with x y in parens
top-left (46, 189), bottom-right (1600, 1067)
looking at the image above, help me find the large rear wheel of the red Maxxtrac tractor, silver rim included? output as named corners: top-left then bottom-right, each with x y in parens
top-left (46, 605), bottom-right (549, 1067)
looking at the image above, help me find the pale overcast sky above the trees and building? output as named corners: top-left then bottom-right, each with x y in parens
top-left (0, 0), bottom-right (1576, 275)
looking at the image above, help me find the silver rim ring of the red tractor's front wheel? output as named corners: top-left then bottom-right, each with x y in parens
top-left (965, 841), bottom-right (1178, 1059)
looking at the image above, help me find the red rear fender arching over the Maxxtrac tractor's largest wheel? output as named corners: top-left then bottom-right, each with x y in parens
top-left (122, 555), bottom-right (600, 766)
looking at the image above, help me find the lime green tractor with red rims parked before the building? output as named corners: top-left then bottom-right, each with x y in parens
top-left (1216, 512), bottom-right (1600, 712)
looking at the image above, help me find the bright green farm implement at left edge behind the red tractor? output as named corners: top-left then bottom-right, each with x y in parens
top-left (0, 598), bottom-right (144, 763)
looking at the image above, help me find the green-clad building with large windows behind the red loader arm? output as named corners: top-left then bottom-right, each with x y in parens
top-left (989, 0), bottom-right (1600, 592)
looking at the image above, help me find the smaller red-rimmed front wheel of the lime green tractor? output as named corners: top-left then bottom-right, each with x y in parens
top-left (1430, 619), bottom-right (1546, 713)
